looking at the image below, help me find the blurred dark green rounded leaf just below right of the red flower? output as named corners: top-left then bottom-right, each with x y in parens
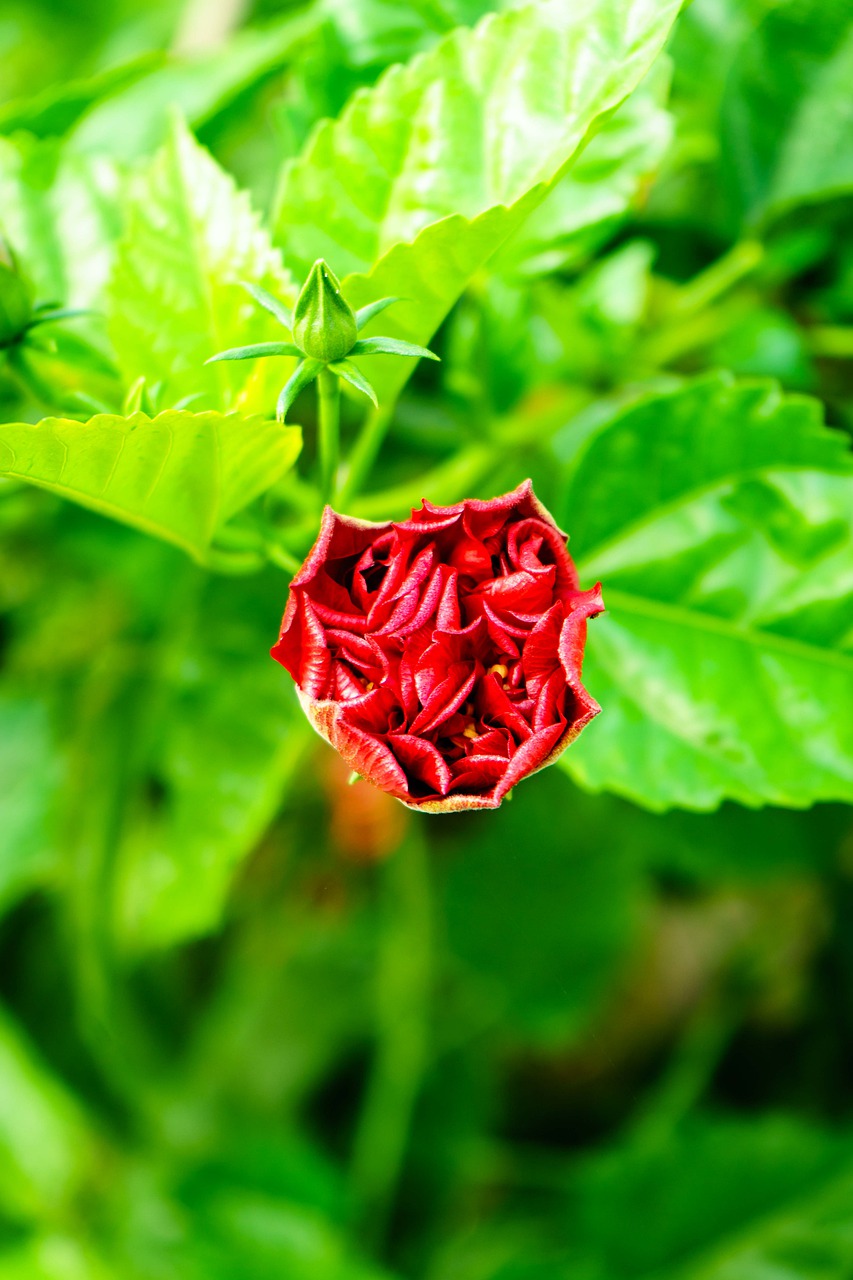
top-left (442, 771), bottom-right (644, 1043)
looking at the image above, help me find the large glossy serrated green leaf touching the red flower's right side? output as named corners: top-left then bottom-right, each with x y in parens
top-left (557, 376), bottom-right (853, 809)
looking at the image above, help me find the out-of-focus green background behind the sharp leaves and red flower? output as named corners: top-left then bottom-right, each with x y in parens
top-left (0, 0), bottom-right (853, 1280)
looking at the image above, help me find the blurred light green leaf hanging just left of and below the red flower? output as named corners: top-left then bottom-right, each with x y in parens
top-left (113, 573), bottom-right (310, 951)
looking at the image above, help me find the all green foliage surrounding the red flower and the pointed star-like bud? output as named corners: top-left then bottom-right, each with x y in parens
top-left (0, 0), bottom-right (853, 1280)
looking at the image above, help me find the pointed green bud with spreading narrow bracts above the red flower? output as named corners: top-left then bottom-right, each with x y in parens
top-left (207, 257), bottom-right (438, 422)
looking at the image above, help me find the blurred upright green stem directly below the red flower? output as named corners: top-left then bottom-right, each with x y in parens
top-left (351, 818), bottom-right (432, 1249)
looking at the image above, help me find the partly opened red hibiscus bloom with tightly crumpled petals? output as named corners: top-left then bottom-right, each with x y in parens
top-left (273, 480), bottom-right (603, 813)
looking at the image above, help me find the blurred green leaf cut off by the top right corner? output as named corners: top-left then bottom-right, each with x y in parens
top-left (722, 0), bottom-right (853, 220)
